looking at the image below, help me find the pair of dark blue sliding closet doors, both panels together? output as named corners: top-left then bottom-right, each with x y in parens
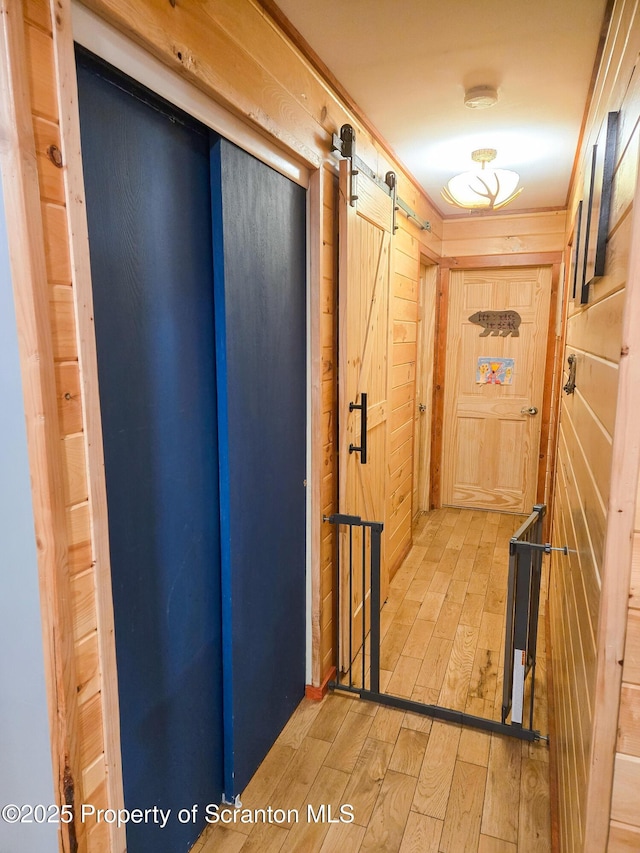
top-left (78, 49), bottom-right (306, 853)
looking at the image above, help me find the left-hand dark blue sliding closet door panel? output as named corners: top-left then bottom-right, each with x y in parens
top-left (78, 54), bottom-right (223, 853)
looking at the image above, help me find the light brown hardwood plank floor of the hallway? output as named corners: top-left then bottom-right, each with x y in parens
top-left (193, 508), bottom-right (551, 853)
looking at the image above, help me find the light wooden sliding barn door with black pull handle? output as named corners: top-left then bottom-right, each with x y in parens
top-left (339, 160), bottom-right (393, 667)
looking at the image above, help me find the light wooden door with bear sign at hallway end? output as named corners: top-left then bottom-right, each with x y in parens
top-left (442, 267), bottom-right (551, 512)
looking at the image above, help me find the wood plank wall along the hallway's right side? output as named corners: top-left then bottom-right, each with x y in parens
top-left (550, 0), bottom-right (640, 853)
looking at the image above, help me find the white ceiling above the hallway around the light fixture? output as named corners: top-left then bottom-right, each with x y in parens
top-left (277, 0), bottom-right (606, 215)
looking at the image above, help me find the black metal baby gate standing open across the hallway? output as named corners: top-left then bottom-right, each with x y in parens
top-left (324, 504), bottom-right (567, 741)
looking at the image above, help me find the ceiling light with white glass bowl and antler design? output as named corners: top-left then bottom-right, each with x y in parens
top-left (442, 148), bottom-right (523, 210)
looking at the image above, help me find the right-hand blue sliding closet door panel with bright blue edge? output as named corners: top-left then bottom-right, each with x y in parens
top-left (211, 139), bottom-right (306, 800)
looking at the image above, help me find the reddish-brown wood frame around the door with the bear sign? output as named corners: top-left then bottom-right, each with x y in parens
top-left (430, 252), bottom-right (564, 509)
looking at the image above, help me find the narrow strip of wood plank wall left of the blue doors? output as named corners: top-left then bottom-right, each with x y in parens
top-left (3, 0), bottom-right (124, 850)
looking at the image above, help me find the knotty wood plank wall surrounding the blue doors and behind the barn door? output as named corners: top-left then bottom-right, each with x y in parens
top-left (5, 0), bottom-right (441, 840)
